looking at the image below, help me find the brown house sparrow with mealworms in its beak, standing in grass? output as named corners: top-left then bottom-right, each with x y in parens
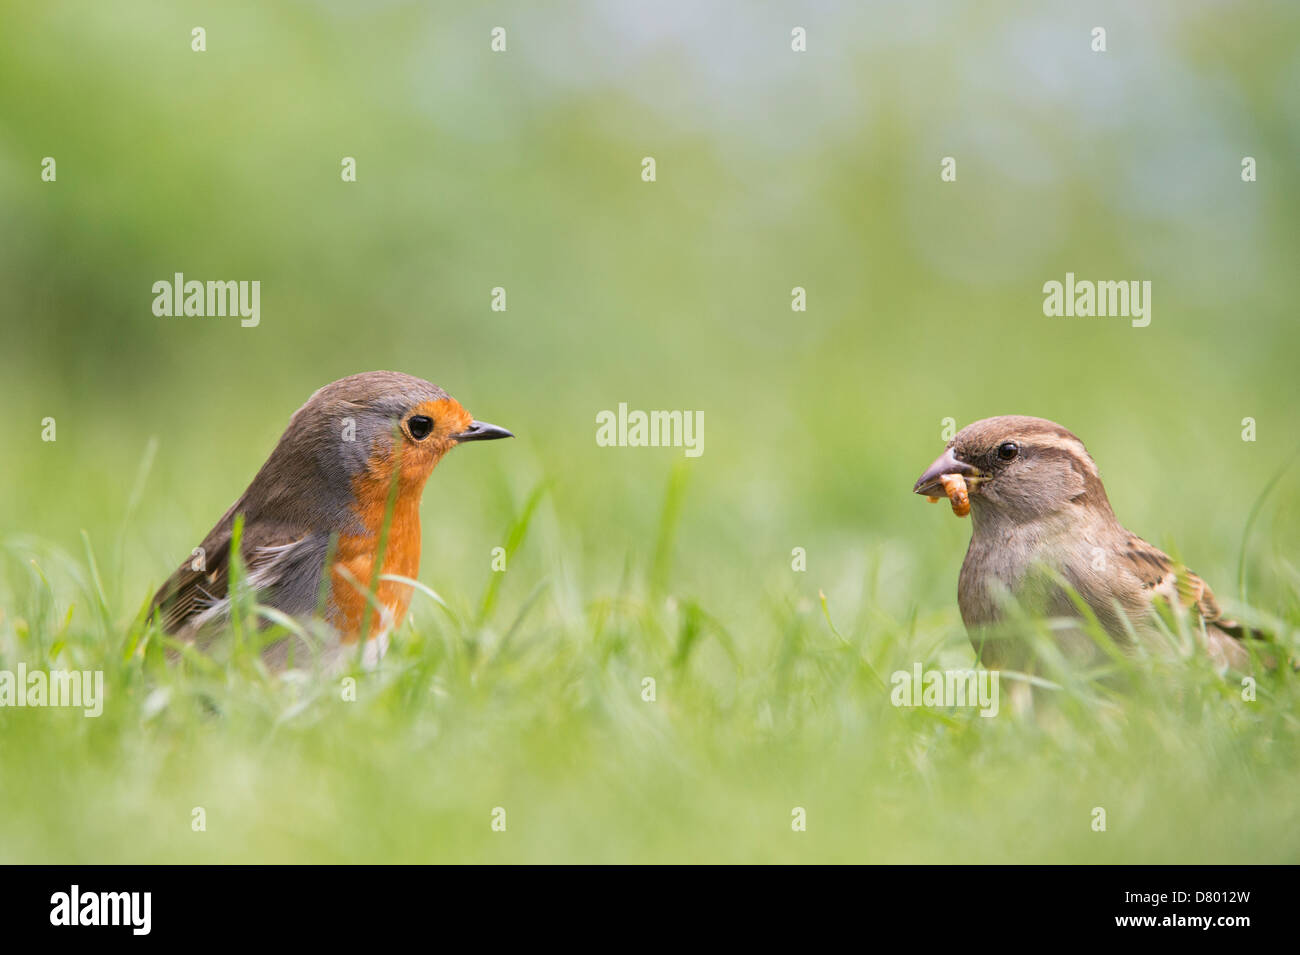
top-left (913, 414), bottom-right (1249, 669)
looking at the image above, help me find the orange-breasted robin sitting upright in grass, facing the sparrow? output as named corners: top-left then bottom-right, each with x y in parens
top-left (150, 372), bottom-right (514, 665)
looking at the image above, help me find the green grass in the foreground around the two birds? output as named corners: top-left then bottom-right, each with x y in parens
top-left (0, 470), bottom-right (1300, 863)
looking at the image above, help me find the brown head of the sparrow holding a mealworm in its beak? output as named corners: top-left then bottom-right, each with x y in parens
top-left (913, 414), bottom-right (1110, 521)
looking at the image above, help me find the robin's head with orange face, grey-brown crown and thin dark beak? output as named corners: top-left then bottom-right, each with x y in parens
top-left (250, 372), bottom-right (514, 517)
